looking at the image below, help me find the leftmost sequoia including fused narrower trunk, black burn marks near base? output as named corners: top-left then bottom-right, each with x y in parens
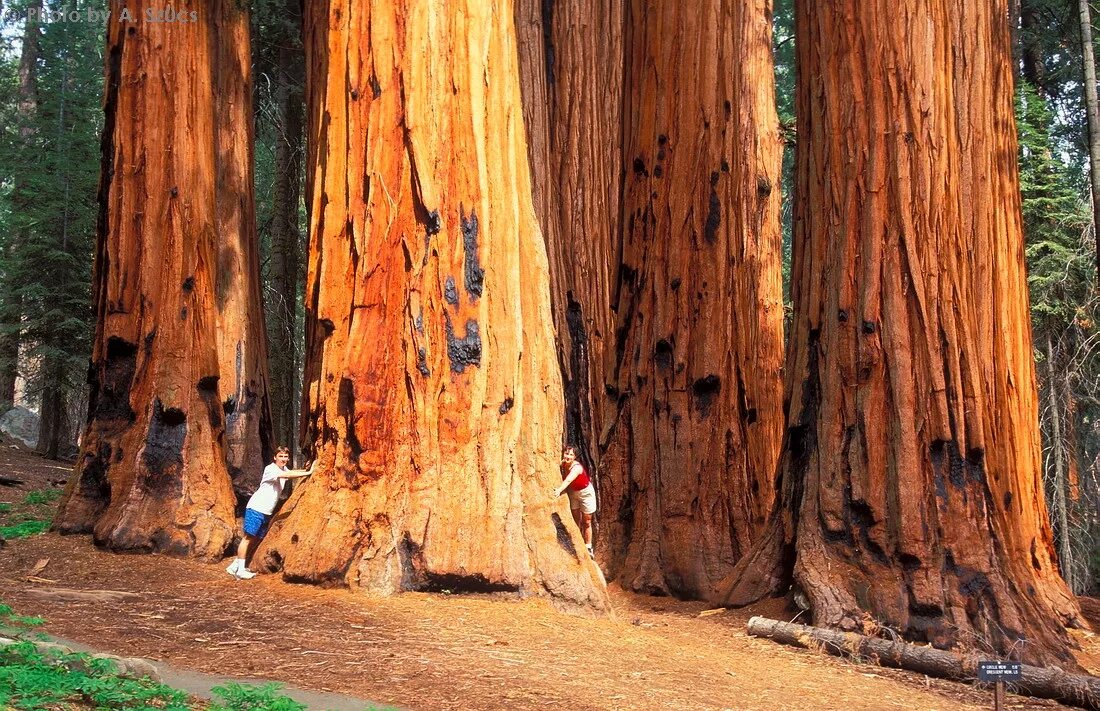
top-left (55, 0), bottom-right (266, 558)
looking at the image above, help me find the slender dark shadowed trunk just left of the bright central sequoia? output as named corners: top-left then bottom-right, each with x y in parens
top-left (268, 0), bottom-right (305, 462)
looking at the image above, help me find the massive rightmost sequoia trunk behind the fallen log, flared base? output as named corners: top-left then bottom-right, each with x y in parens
top-left (718, 0), bottom-right (1079, 666)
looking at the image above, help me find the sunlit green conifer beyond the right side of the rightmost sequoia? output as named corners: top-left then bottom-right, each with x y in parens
top-left (1016, 81), bottom-right (1100, 593)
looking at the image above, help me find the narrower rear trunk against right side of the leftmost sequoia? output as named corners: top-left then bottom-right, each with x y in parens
top-left (212, 0), bottom-right (275, 500)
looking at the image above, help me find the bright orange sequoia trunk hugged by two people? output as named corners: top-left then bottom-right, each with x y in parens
top-left (256, 0), bottom-right (607, 610)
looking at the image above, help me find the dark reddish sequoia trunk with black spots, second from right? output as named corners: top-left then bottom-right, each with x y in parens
top-left (601, 0), bottom-right (782, 598)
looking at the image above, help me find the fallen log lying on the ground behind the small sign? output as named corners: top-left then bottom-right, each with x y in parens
top-left (748, 617), bottom-right (1100, 709)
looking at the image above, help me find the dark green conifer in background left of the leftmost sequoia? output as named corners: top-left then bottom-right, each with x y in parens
top-left (0, 1), bottom-right (103, 457)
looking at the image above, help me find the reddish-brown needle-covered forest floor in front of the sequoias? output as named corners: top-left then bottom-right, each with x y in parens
top-left (0, 446), bottom-right (1100, 711)
